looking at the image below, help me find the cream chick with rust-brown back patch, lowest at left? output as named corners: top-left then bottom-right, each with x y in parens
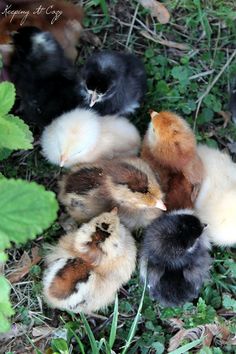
top-left (43, 209), bottom-right (136, 313)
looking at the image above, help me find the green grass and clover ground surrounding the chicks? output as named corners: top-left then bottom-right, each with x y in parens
top-left (0, 0), bottom-right (236, 354)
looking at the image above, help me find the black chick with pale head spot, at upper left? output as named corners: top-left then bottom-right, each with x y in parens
top-left (9, 27), bottom-right (79, 127)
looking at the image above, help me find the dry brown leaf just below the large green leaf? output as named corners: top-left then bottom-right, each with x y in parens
top-left (7, 247), bottom-right (42, 283)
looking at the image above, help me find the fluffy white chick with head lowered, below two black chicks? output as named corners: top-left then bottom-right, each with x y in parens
top-left (41, 108), bottom-right (140, 167)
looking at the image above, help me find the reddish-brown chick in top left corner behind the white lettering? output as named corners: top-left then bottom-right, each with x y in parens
top-left (0, 0), bottom-right (83, 60)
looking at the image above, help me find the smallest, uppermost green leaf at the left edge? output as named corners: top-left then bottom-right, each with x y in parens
top-left (0, 81), bottom-right (16, 116)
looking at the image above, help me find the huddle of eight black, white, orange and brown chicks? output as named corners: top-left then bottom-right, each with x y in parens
top-left (2, 0), bottom-right (236, 313)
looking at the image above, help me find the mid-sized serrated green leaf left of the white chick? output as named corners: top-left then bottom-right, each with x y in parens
top-left (0, 114), bottom-right (33, 150)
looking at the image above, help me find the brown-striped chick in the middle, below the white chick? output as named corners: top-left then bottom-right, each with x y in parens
top-left (58, 157), bottom-right (166, 230)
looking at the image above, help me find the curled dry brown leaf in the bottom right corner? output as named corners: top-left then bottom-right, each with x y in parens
top-left (168, 324), bottom-right (230, 352)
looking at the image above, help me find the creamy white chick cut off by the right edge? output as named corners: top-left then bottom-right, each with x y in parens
top-left (195, 145), bottom-right (236, 246)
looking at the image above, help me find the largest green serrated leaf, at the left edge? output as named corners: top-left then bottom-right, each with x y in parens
top-left (0, 179), bottom-right (58, 244)
